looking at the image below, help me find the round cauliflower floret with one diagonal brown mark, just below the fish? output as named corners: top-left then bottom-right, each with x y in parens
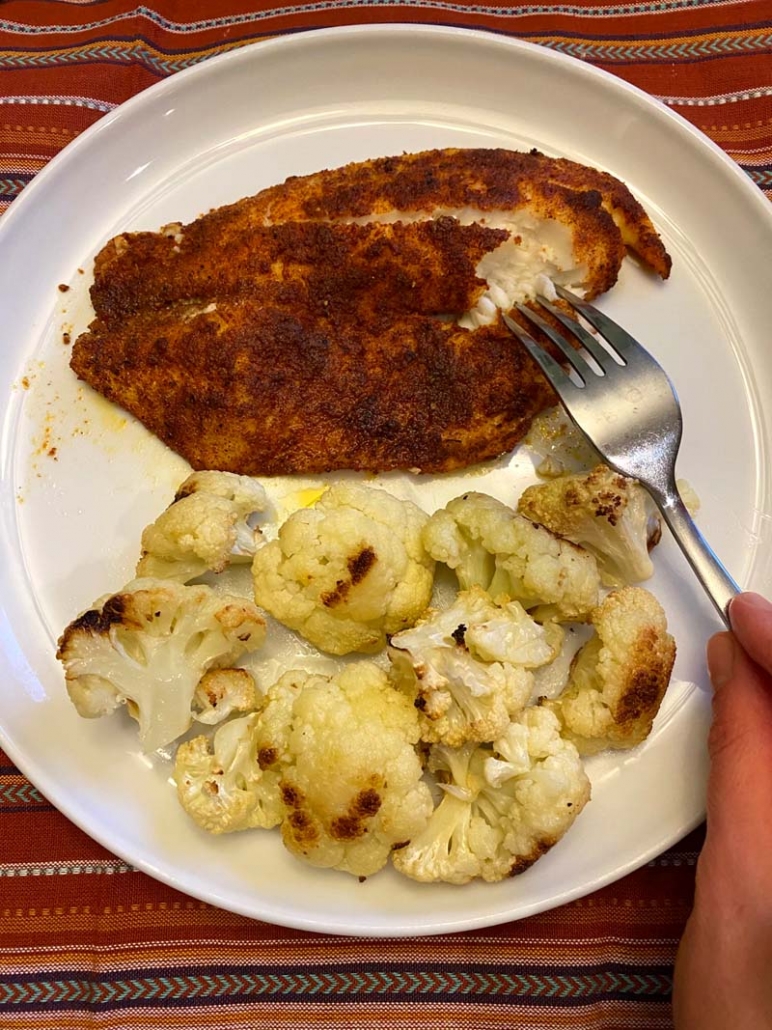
top-left (252, 482), bottom-right (434, 655)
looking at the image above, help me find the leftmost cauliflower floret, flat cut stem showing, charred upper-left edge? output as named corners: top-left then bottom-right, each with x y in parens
top-left (57, 579), bottom-right (266, 751)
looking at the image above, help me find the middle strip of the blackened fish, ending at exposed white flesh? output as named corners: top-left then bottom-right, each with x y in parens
top-left (91, 215), bottom-right (508, 324)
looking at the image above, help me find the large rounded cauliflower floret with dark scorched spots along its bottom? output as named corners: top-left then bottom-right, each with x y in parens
top-left (256, 661), bottom-right (432, 877)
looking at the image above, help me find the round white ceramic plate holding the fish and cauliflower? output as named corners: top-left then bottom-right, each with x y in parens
top-left (0, 26), bottom-right (772, 935)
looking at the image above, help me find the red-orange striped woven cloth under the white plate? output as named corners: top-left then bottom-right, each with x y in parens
top-left (0, 0), bottom-right (772, 1030)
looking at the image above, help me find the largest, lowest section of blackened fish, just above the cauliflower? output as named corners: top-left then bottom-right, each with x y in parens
top-left (72, 295), bottom-right (555, 476)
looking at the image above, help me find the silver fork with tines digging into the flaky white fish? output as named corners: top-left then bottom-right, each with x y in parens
top-left (503, 285), bottom-right (740, 625)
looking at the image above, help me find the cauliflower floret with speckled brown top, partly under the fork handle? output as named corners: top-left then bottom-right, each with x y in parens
top-left (518, 465), bottom-right (662, 586)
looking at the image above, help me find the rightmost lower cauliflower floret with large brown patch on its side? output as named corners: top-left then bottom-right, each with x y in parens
top-left (546, 586), bottom-right (675, 755)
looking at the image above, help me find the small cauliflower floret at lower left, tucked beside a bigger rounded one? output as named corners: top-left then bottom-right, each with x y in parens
top-left (174, 713), bottom-right (282, 833)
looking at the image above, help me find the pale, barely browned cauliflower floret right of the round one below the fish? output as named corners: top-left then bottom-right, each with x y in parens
top-left (423, 493), bottom-right (600, 619)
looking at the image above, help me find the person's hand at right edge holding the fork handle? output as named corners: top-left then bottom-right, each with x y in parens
top-left (673, 593), bottom-right (772, 1030)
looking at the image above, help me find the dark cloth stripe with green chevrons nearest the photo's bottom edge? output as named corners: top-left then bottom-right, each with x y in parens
top-left (0, 963), bottom-right (672, 1012)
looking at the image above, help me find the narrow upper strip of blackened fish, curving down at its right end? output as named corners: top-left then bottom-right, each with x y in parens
top-left (180, 147), bottom-right (671, 297)
